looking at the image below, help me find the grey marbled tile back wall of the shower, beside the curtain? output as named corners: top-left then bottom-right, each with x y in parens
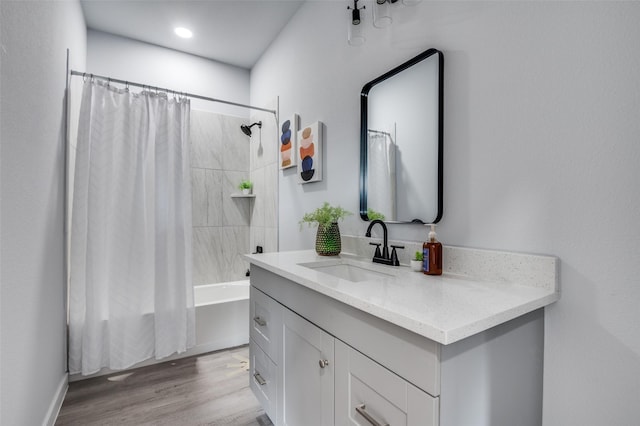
top-left (190, 110), bottom-right (251, 285)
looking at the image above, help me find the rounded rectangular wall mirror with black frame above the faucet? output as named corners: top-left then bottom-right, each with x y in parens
top-left (360, 49), bottom-right (444, 223)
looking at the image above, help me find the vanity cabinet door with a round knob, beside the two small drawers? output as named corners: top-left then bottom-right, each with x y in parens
top-left (277, 309), bottom-right (334, 426)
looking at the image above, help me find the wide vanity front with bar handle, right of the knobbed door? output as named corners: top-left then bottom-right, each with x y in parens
top-left (335, 340), bottom-right (438, 426)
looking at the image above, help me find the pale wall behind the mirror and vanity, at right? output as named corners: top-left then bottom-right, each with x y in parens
top-left (251, 1), bottom-right (640, 426)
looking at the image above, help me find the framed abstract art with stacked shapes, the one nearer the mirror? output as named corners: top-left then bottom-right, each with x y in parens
top-left (296, 121), bottom-right (322, 183)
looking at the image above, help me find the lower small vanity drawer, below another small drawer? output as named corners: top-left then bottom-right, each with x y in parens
top-left (249, 339), bottom-right (278, 420)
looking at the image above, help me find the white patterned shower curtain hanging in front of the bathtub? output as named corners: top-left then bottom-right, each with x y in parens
top-left (69, 80), bottom-right (195, 374)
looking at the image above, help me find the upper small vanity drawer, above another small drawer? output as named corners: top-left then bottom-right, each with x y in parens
top-left (249, 286), bottom-right (282, 361)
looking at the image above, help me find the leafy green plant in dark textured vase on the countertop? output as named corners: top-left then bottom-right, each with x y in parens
top-left (300, 201), bottom-right (352, 256)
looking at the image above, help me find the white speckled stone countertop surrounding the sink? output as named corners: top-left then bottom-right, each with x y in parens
top-left (245, 250), bottom-right (559, 345)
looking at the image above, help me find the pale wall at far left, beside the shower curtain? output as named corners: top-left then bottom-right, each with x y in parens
top-left (0, 0), bottom-right (86, 425)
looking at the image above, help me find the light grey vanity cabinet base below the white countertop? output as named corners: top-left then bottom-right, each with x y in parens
top-left (250, 264), bottom-right (544, 426)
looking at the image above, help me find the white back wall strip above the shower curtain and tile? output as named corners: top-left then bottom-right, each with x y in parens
top-left (85, 30), bottom-right (249, 117)
